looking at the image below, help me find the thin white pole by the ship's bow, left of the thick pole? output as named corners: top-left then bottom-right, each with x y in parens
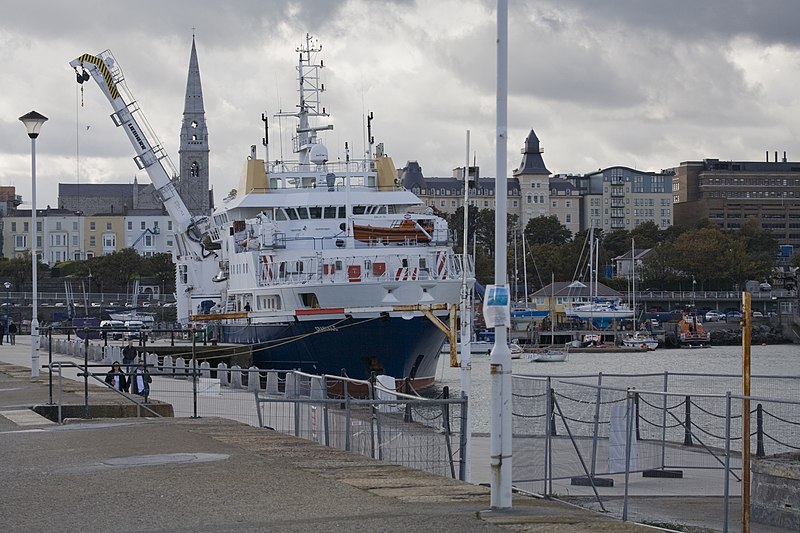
top-left (461, 130), bottom-right (475, 481)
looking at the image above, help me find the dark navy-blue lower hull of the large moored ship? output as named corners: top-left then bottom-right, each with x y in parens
top-left (220, 317), bottom-right (445, 389)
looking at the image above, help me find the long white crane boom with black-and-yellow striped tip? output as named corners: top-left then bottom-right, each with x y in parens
top-left (69, 50), bottom-right (206, 238)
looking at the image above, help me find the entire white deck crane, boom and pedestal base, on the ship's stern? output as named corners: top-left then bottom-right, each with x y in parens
top-left (69, 50), bottom-right (220, 320)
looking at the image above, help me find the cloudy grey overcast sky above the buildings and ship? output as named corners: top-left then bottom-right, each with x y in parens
top-left (0, 0), bottom-right (800, 207)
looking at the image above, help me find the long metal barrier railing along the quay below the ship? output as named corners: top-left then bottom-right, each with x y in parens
top-left (42, 337), bottom-right (468, 479)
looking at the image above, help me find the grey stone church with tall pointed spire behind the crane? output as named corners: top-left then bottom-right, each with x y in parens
top-left (58, 36), bottom-right (214, 216)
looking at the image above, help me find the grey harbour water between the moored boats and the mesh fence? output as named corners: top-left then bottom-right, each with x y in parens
top-left (436, 344), bottom-right (800, 434)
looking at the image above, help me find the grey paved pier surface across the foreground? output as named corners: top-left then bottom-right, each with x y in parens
top-left (0, 336), bottom-right (780, 533)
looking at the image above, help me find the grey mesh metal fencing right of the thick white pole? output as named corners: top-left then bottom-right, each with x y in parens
top-left (512, 373), bottom-right (800, 531)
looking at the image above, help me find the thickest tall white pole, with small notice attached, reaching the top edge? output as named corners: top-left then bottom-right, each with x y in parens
top-left (490, 0), bottom-right (511, 509)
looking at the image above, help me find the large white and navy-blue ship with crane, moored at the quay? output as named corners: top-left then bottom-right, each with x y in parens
top-left (70, 36), bottom-right (474, 388)
